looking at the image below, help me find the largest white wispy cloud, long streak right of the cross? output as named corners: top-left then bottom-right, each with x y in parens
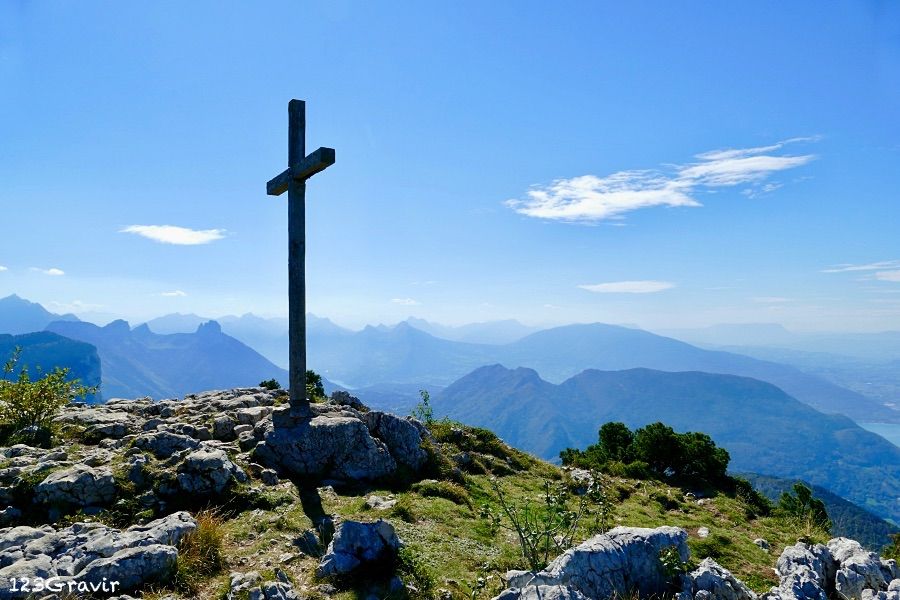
top-left (505, 138), bottom-right (818, 223)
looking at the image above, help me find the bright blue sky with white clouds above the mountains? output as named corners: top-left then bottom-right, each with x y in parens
top-left (0, 0), bottom-right (900, 330)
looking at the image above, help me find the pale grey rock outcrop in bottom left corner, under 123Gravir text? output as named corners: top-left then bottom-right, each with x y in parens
top-left (0, 512), bottom-right (197, 600)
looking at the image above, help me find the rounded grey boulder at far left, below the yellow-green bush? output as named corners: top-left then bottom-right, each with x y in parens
top-left (34, 465), bottom-right (116, 507)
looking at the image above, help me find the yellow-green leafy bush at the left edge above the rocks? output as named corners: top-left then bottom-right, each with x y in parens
top-left (0, 348), bottom-right (97, 447)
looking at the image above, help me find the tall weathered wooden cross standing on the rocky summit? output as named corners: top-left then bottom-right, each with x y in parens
top-left (266, 100), bottom-right (334, 418)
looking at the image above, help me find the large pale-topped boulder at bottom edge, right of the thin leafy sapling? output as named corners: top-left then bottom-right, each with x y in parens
top-left (500, 527), bottom-right (690, 600)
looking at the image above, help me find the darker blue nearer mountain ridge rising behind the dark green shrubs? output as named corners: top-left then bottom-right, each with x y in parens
top-left (433, 365), bottom-right (900, 523)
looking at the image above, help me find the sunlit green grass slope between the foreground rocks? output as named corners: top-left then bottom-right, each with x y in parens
top-left (174, 422), bottom-right (822, 599)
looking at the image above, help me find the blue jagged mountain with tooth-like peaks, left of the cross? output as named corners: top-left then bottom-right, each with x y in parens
top-left (47, 321), bottom-right (287, 400)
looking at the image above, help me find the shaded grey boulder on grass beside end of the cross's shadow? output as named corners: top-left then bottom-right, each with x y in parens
top-left (316, 519), bottom-right (400, 577)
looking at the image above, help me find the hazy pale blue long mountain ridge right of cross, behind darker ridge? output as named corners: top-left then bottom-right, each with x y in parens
top-left (309, 322), bottom-right (900, 423)
